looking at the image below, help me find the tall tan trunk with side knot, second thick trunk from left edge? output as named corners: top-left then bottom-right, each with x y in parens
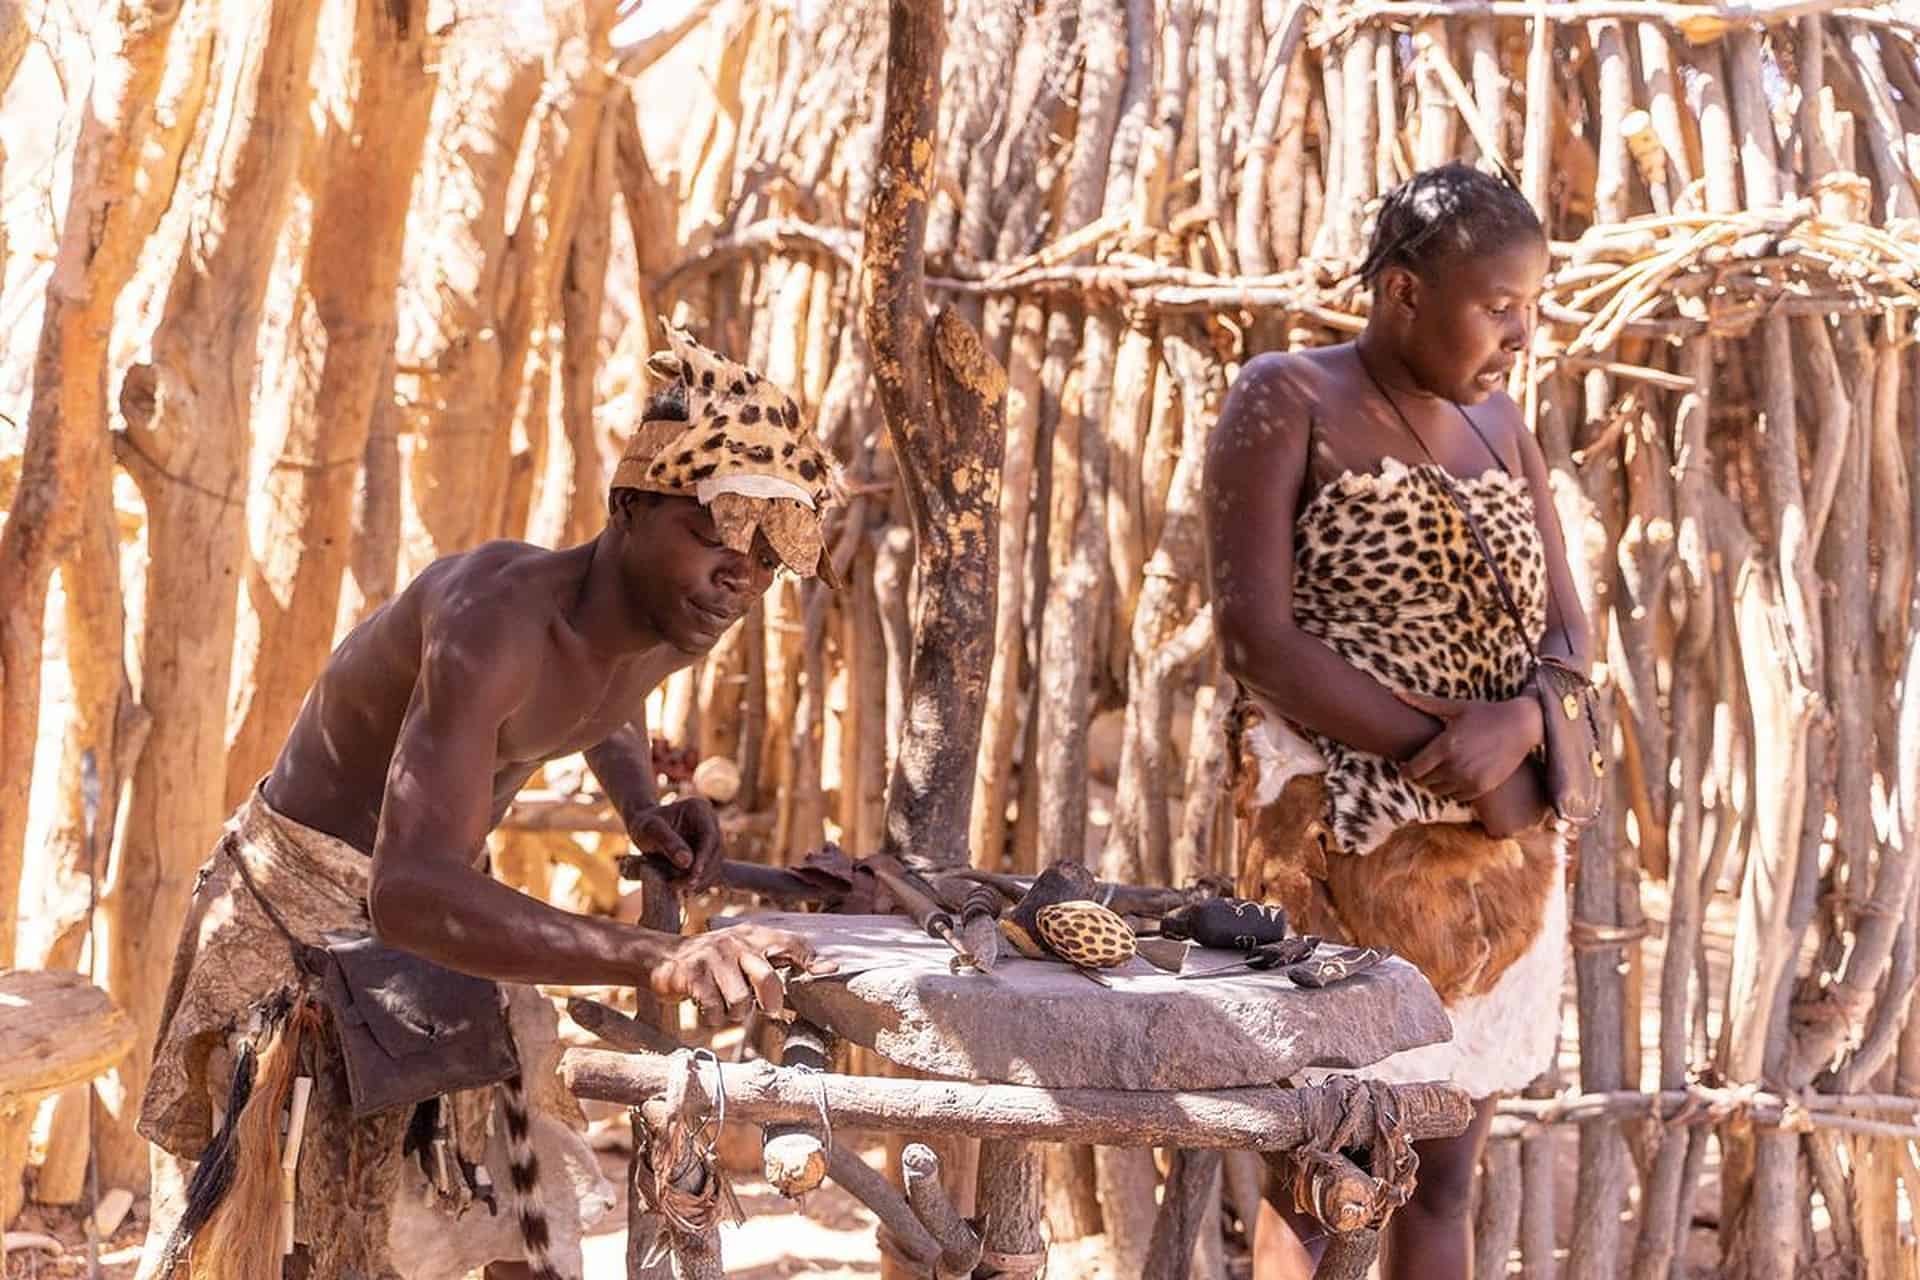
top-left (100, 0), bottom-right (319, 1186)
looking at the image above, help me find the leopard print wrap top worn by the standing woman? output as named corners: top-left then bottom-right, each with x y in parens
top-left (1294, 459), bottom-right (1546, 854)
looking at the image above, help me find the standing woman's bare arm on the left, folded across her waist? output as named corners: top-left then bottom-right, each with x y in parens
top-left (1204, 355), bottom-right (1440, 760)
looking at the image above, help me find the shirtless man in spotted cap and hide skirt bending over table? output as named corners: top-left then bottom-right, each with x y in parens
top-left (140, 330), bottom-right (839, 1280)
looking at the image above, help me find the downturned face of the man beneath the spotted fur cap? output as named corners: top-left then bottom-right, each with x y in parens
top-left (612, 495), bottom-right (780, 656)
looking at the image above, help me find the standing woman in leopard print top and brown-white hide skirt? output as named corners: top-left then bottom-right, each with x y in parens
top-left (1206, 165), bottom-right (1592, 1280)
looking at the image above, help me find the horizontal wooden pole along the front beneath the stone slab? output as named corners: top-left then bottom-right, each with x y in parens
top-left (561, 1048), bottom-right (1471, 1150)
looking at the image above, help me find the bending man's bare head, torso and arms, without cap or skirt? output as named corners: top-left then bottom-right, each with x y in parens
top-left (263, 474), bottom-right (808, 1023)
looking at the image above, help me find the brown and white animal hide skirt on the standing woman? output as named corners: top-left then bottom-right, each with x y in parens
top-left (1233, 700), bottom-right (1567, 1098)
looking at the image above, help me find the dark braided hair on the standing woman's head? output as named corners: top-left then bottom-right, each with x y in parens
top-left (1359, 161), bottom-right (1546, 284)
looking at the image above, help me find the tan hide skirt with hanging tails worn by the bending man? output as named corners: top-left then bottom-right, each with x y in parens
top-left (140, 789), bottom-right (612, 1280)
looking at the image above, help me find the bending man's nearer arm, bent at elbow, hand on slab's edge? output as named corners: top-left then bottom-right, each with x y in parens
top-left (369, 616), bottom-right (810, 1021)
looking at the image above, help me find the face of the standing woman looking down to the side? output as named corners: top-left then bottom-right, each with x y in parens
top-left (1380, 236), bottom-right (1548, 405)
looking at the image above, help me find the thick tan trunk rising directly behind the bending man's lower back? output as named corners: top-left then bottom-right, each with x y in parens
top-left (227, 0), bottom-right (436, 806)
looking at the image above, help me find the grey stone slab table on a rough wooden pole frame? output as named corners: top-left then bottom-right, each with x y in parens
top-left (563, 913), bottom-right (1469, 1276)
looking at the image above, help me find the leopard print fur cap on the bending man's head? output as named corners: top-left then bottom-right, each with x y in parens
top-left (612, 324), bottom-right (845, 587)
